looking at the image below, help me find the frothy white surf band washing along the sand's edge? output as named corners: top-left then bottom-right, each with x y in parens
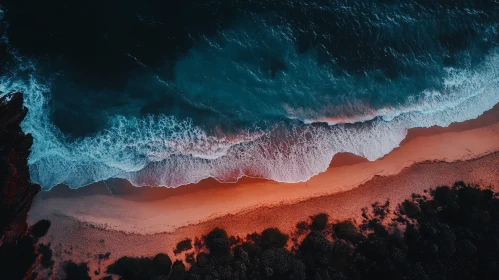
top-left (0, 46), bottom-right (499, 188)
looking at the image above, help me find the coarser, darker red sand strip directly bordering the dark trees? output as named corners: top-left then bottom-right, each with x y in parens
top-left (33, 152), bottom-right (499, 275)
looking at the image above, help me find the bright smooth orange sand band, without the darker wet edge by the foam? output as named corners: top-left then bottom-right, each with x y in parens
top-left (28, 121), bottom-right (499, 234)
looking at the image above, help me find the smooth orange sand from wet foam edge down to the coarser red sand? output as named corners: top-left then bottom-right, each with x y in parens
top-left (30, 106), bottom-right (499, 235)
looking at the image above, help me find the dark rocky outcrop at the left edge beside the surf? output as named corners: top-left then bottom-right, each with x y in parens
top-left (0, 93), bottom-right (53, 279)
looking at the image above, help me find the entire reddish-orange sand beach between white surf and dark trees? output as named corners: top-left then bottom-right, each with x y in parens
top-left (30, 107), bottom-right (499, 278)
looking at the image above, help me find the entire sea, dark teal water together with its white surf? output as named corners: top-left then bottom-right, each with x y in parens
top-left (0, 0), bottom-right (499, 188)
